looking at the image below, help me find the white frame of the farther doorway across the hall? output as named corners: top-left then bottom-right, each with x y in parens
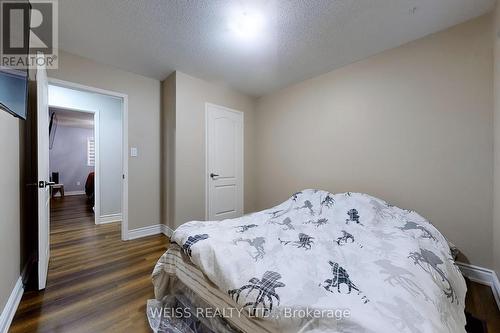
top-left (49, 105), bottom-right (101, 224)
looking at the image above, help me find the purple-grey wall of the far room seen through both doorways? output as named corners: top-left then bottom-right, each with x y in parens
top-left (50, 126), bottom-right (94, 192)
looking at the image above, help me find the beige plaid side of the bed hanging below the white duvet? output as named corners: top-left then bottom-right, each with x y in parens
top-left (147, 244), bottom-right (280, 333)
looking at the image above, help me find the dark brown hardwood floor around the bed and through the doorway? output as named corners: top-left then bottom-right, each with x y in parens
top-left (6, 196), bottom-right (500, 333)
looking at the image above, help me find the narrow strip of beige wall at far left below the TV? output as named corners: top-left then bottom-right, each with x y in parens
top-left (0, 110), bottom-right (21, 313)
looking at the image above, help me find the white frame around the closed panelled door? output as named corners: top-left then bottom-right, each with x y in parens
top-left (205, 102), bottom-right (245, 221)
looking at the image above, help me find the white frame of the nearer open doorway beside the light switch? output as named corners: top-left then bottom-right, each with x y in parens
top-left (49, 77), bottom-right (129, 241)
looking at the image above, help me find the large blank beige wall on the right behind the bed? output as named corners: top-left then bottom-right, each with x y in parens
top-left (256, 15), bottom-right (493, 267)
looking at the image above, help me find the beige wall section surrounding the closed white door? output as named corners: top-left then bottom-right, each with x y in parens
top-left (164, 72), bottom-right (255, 228)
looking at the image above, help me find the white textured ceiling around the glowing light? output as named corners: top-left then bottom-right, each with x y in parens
top-left (59, 0), bottom-right (495, 96)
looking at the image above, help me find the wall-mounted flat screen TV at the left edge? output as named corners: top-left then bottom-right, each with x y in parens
top-left (0, 68), bottom-right (28, 119)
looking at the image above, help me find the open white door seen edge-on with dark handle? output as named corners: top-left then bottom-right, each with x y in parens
top-left (36, 54), bottom-right (51, 290)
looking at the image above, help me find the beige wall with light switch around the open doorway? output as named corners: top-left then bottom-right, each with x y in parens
top-left (48, 52), bottom-right (161, 230)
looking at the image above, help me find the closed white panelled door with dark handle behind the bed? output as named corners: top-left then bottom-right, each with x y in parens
top-left (206, 104), bottom-right (243, 220)
